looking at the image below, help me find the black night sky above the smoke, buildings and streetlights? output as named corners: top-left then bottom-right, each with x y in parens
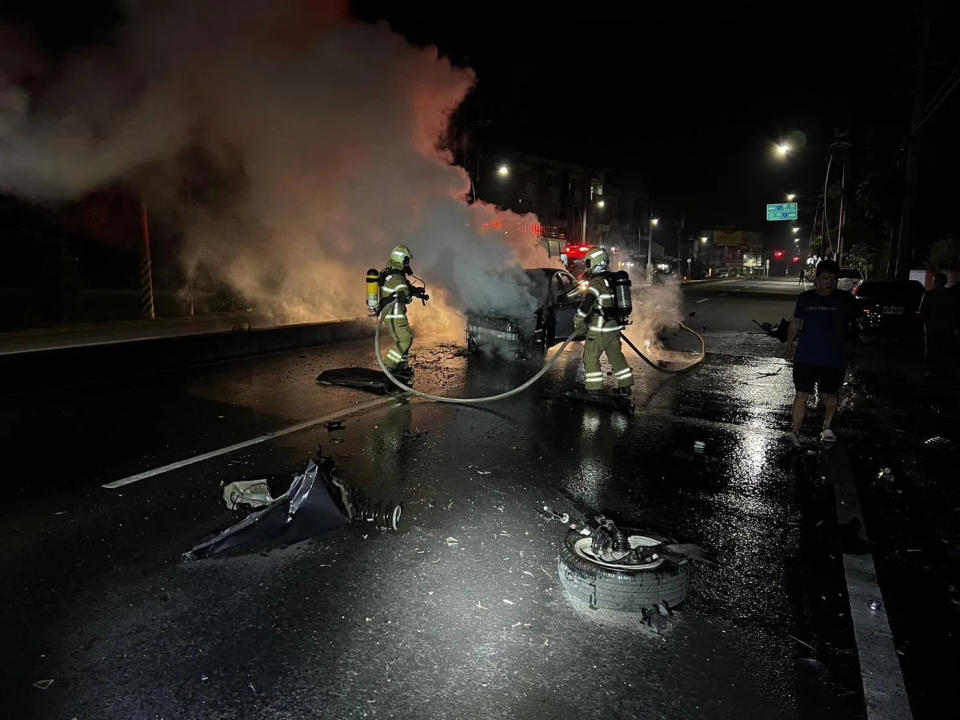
top-left (4, 0), bottom-right (960, 245)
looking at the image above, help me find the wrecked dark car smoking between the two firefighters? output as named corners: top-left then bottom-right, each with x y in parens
top-left (467, 268), bottom-right (583, 356)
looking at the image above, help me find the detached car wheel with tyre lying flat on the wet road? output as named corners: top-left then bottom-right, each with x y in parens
top-left (557, 528), bottom-right (690, 612)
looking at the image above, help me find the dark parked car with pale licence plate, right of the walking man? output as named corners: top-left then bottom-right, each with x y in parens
top-left (853, 280), bottom-right (924, 337)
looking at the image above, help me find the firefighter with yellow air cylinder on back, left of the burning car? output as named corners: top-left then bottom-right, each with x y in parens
top-left (380, 245), bottom-right (430, 381)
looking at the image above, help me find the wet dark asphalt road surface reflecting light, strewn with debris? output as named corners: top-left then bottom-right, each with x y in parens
top-left (0, 281), bottom-right (863, 718)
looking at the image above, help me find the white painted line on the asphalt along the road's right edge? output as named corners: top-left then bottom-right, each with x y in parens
top-left (823, 443), bottom-right (913, 720)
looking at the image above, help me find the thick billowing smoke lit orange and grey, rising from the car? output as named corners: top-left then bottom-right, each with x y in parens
top-left (0, 0), bottom-right (551, 328)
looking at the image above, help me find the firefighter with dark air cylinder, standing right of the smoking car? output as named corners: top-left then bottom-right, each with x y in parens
top-left (574, 247), bottom-right (633, 398)
